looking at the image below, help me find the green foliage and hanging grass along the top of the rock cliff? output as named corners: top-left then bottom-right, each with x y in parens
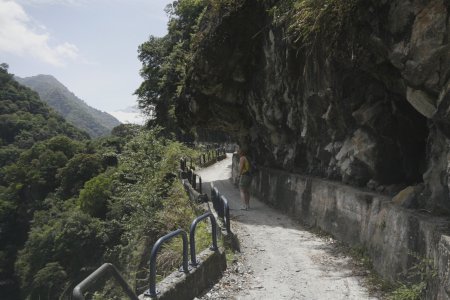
top-left (136, 0), bottom-right (359, 132)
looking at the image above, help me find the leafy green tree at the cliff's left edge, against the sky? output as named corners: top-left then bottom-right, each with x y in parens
top-left (135, 0), bottom-right (208, 137)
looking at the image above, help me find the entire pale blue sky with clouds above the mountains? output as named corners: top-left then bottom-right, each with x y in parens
top-left (0, 0), bottom-right (172, 111)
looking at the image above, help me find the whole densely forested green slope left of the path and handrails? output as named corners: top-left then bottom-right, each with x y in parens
top-left (0, 64), bottom-right (204, 299)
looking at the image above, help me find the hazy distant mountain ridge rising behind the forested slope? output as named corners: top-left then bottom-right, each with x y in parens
top-left (16, 75), bottom-right (120, 137)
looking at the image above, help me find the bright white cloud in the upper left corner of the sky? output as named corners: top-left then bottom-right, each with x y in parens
top-left (0, 0), bottom-right (79, 66)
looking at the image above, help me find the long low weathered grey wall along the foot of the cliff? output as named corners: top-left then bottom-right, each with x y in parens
top-left (233, 156), bottom-right (450, 299)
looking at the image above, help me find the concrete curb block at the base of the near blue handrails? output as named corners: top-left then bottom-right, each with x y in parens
top-left (139, 249), bottom-right (227, 300)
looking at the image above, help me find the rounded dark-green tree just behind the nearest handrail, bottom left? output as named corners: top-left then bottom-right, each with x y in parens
top-left (15, 206), bottom-right (106, 299)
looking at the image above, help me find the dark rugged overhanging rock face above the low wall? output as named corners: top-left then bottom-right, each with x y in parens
top-left (182, 0), bottom-right (450, 212)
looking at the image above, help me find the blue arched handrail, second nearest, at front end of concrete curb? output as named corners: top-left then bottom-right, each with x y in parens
top-left (144, 229), bottom-right (189, 297)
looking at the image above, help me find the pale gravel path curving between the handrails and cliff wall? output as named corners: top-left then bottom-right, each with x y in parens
top-left (198, 156), bottom-right (376, 300)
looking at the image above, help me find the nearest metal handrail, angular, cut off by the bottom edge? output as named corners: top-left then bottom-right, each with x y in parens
top-left (72, 263), bottom-right (139, 300)
